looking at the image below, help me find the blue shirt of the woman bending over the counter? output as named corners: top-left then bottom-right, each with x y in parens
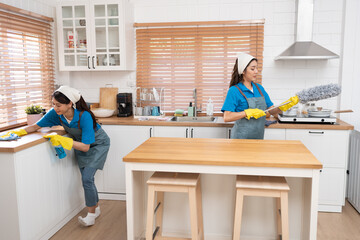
top-left (36, 108), bottom-right (100, 144)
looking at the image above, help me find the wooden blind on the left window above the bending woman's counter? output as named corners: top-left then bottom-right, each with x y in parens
top-left (0, 4), bottom-right (54, 129)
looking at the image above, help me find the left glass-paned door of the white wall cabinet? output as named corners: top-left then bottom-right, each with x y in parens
top-left (60, 5), bottom-right (89, 68)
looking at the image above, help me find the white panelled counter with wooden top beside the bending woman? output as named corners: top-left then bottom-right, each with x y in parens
top-left (0, 127), bottom-right (85, 240)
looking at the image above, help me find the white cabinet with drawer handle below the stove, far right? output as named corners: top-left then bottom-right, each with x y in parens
top-left (286, 129), bottom-right (349, 212)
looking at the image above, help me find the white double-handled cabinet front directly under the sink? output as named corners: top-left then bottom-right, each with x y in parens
top-left (154, 126), bottom-right (226, 138)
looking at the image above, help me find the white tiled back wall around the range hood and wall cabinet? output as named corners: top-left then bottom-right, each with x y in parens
top-left (3, 0), bottom-right (360, 125)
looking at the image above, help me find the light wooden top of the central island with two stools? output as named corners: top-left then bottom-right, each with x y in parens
top-left (123, 137), bottom-right (322, 169)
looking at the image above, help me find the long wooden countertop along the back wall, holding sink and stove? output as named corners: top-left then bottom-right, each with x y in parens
top-left (98, 116), bottom-right (354, 130)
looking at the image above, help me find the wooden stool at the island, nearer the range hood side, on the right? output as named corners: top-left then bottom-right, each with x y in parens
top-left (233, 176), bottom-right (290, 240)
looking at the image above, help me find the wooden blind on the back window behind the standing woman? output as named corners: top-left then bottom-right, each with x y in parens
top-left (135, 20), bottom-right (264, 112)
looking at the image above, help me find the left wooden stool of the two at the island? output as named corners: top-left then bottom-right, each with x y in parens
top-left (146, 172), bottom-right (204, 240)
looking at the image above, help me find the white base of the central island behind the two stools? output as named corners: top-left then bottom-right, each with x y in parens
top-left (126, 163), bottom-right (319, 240)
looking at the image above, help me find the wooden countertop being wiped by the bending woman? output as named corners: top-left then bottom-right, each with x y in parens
top-left (0, 126), bottom-right (66, 153)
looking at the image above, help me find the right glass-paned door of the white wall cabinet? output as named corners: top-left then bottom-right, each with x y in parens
top-left (93, 4), bottom-right (120, 67)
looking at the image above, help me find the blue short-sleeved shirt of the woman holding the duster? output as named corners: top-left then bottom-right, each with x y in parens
top-left (221, 83), bottom-right (274, 112)
